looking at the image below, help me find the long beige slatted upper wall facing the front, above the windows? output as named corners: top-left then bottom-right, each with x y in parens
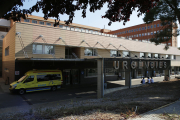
top-left (16, 23), bottom-right (180, 58)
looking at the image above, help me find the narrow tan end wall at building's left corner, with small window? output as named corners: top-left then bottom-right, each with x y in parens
top-left (2, 25), bottom-right (16, 83)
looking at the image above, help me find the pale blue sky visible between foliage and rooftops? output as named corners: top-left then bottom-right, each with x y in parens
top-left (22, 0), bottom-right (180, 47)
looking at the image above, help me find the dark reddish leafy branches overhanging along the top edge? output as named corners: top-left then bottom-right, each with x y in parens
top-left (0, 0), bottom-right (159, 26)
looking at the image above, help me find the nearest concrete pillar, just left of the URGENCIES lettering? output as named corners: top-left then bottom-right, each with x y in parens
top-left (97, 58), bottom-right (104, 98)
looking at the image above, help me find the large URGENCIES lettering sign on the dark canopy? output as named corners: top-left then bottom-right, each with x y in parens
top-left (113, 61), bottom-right (167, 69)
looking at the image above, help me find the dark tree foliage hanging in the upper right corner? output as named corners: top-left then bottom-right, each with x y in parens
top-left (144, 0), bottom-right (180, 50)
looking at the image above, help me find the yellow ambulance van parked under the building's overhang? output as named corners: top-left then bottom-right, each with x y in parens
top-left (9, 70), bottom-right (63, 95)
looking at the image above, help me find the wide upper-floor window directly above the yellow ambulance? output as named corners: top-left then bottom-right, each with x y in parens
top-left (33, 44), bottom-right (54, 54)
